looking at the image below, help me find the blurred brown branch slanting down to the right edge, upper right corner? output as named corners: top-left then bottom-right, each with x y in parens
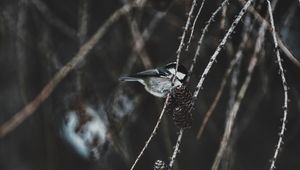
top-left (239, 0), bottom-right (300, 69)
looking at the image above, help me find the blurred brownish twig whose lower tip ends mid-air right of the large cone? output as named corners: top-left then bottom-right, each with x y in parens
top-left (197, 15), bottom-right (252, 140)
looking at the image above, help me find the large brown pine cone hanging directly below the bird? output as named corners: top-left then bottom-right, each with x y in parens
top-left (166, 86), bottom-right (193, 128)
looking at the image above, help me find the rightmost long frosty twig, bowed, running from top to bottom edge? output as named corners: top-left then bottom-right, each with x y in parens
top-left (267, 0), bottom-right (288, 170)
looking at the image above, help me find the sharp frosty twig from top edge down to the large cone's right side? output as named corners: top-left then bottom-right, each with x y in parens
top-left (193, 0), bottom-right (254, 100)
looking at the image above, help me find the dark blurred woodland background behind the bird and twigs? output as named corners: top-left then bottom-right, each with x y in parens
top-left (0, 0), bottom-right (300, 170)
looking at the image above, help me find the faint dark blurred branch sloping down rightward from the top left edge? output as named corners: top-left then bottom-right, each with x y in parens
top-left (31, 0), bottom-right (77, 41)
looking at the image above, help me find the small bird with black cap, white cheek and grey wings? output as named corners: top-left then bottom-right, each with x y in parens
top-left (119, 62), bottom-right (188, 97)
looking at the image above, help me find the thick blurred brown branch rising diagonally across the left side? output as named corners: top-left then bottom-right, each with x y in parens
top-left (0, 5), bottom-right (133, 137)
